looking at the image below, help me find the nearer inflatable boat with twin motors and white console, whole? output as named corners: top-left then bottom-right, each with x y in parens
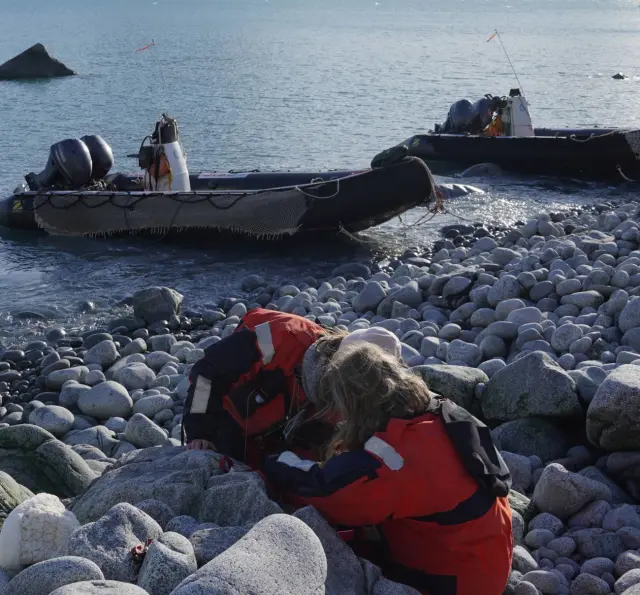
top-left (0, 114), bottom-right (436, 238)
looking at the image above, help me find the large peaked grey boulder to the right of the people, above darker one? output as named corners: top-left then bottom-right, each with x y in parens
top-left (482, 351), bottom-right (582, 421)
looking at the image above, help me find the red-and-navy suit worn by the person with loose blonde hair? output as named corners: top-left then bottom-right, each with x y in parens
top-left (264, 402), bottom-right (513, 595)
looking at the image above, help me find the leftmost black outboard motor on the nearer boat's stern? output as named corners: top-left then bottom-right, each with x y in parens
top-left (25, 138), bottom-right (93, 191)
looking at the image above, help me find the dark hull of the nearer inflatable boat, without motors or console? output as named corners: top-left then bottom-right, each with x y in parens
top-left (0, 158), bottom-right (432, 242)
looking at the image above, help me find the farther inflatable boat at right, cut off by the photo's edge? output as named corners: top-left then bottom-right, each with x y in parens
top-left (401, 89), bottom-right (640, 181)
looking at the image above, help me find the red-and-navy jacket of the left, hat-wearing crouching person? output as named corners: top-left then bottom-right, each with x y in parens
top-left (183, 308), bottom-right (325, 466)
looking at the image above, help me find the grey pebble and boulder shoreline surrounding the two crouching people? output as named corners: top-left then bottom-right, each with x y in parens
top-left (0, 202), bottom-right (640, 595)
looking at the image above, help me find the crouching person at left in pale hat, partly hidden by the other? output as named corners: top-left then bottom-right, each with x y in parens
top-left (183, 308), bottom-right (400, 468)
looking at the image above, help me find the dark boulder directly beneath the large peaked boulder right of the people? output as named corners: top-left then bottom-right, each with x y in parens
top-left (491, 417), bottom-right (571, 461)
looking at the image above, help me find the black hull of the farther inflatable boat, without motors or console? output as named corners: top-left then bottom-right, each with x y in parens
top-left (404, 128), bottom-right (640, 181)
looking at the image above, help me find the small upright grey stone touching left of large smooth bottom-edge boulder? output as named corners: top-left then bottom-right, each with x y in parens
top-left (137, 533), bottom-right (198, 595)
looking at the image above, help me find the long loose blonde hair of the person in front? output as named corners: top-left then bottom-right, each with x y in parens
top-left (320, 342), bottom-right (431, 458)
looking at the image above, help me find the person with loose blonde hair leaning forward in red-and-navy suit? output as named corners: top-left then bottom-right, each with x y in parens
top-left (263, 344), bottom-right (513, 595)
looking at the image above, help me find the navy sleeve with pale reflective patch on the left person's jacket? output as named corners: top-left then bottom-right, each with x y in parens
top-left (183, 329), bottom-right (260, 447)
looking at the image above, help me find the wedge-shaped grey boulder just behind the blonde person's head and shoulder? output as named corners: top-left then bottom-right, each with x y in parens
top-left (411, 364), bottom-right (489, 409)
